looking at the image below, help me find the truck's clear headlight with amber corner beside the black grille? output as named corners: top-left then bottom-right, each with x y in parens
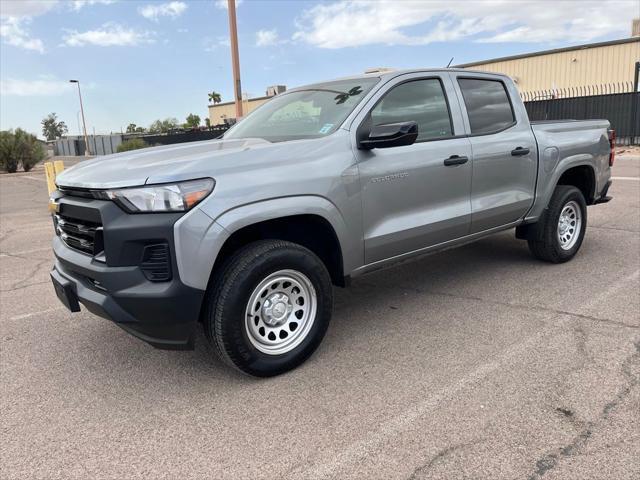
top-left (105, 178), bottom-right (216, 213)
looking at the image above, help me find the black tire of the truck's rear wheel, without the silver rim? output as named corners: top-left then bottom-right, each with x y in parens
top-left (527, 185), bottom-right (587, 263)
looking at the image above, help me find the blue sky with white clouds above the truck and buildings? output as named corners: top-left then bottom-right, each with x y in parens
top-left (0, 0), bottom-right (640, 137)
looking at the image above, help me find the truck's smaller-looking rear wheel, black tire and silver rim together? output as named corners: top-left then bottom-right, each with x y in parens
top-left (528, 185), bottom-right (587, 263)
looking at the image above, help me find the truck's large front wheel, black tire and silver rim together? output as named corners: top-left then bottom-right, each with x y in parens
top-left (203, 240), bottom-right (333, 377)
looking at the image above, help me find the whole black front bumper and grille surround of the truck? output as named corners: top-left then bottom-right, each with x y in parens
top-left (51, 194), bottom-right (204, 350)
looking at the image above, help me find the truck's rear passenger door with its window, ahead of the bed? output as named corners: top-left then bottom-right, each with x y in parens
top-left (454, 73), bottom-right (538, 233)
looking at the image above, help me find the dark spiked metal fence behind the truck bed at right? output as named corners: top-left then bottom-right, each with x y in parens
top-left (522, 82), bottom-right (640, 145)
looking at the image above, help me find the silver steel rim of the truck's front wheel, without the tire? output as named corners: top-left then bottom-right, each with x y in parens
top-left (245, 270), bottom-right (318, 355)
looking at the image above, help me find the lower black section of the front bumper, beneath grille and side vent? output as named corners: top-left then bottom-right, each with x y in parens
top-left (51, 229), bottom-right (204, 350)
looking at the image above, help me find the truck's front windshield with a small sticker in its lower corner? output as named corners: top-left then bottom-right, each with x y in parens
top-left (224, 78), bottom-right (379, 142)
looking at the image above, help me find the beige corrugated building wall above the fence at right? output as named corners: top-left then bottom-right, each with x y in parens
top-left (457, 37), bottom-right (640, 96)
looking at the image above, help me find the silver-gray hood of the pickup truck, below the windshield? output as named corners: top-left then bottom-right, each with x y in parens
top-left (56, 138), bottom-right (280, 189)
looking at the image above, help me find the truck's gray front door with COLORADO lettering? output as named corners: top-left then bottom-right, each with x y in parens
top-left (356, 73), bottom-right (471, 263)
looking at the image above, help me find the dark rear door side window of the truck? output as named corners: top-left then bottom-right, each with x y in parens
top-left (458, 78), bottom-right (515, 134)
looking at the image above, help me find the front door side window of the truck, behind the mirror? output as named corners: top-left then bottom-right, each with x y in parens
top-left (371, 78), bottom-right (453, 142)
